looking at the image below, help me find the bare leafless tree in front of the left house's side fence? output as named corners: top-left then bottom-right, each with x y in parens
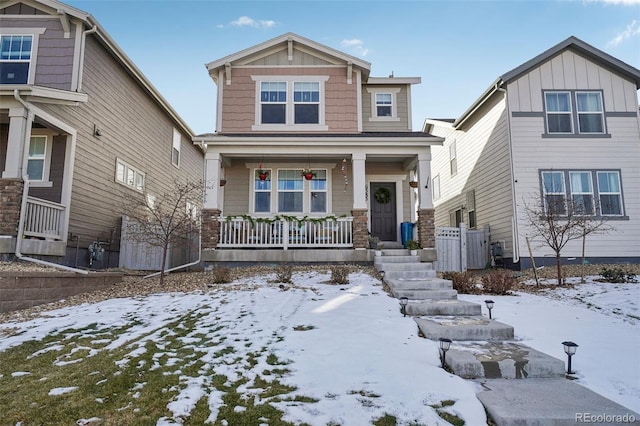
top-left (121, 179), bottom-right (203, 285)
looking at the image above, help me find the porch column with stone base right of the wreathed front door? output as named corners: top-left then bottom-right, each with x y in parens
top-left (418, 152), bottom-right (436, 248)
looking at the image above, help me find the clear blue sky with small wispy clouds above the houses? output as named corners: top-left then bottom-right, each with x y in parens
top-left (67, 0), bottom-right (640, 134)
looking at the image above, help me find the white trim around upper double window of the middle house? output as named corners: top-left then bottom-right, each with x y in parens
top-left (251, 75), bottom-right (329, 132)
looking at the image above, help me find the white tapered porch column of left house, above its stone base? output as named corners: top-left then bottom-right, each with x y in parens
top-left (2, 108), bottom-right (33, 179)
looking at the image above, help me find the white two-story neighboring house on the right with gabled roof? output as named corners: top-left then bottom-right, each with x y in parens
top-left (424, 37), bottom-right (640, 268)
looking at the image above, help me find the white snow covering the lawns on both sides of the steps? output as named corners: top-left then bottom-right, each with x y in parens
top-left (0, 273), bottom-right (640, 426)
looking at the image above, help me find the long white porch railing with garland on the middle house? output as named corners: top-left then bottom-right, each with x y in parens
top-left (218, 217), bottom-right (353, 250)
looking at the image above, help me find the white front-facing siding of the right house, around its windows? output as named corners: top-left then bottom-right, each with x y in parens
top-left (507, 51), bottom-right (640, 258)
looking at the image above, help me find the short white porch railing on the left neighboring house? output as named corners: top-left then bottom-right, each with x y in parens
top-left (24, 197), bottom-right (65, 240)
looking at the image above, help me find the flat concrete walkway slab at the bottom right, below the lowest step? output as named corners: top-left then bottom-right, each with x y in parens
top-left (477, 378), bottom-right (640, 426)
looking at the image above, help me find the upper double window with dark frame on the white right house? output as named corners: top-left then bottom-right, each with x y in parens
top-left (544, 91), bottom-right (605, 135)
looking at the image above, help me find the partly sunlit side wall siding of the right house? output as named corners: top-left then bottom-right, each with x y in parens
top-left (430, 93), bottom-right (513, 257)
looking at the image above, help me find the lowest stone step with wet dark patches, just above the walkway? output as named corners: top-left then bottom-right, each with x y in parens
top-left (445, 342), bottom-right (565, 379)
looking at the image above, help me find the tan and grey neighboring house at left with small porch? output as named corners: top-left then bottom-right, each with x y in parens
top-left (0, 0), bottom-right (204, 268)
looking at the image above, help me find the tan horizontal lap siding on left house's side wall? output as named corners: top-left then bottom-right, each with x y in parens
top-left (40, 36), bottom-right (203, 249)
